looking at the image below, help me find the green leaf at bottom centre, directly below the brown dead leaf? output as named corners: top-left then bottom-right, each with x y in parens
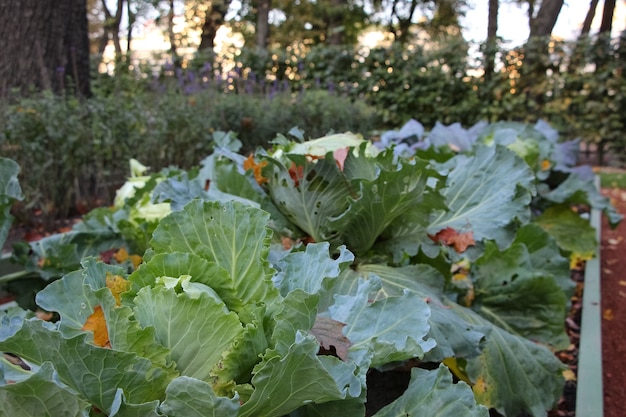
top-left (239, 332), bottom-right (362, 417)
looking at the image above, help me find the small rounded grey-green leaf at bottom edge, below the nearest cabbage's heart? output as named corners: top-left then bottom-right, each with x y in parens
top-left (159, 376), bottom-right (239, 417)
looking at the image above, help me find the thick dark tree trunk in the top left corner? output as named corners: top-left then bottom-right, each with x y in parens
top-left (0, 0), bottom-right (90, 96)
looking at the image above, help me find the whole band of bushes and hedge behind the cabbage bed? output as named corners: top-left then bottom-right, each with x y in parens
top-left (0, 30), bottom-right (626, 224)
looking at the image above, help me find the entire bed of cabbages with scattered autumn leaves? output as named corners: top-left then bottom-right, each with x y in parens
top-left (0, 124), bottom-right (620, 417)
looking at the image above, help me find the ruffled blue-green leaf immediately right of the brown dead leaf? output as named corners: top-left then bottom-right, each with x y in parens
top-left (329, 277), bottom-right (436, 366)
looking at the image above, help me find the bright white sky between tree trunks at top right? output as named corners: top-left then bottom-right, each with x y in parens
top-left (462, 0), bottom-right (626, 45)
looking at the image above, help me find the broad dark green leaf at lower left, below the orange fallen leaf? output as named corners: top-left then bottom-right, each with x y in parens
top-left (0, 316), bottom-right (168, 412)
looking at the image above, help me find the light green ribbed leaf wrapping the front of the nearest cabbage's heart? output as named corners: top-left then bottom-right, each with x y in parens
top-left (134, 287), bottom-right (243, 380)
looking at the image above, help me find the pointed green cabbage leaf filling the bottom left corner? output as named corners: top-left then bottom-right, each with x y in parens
top-left (0, 362), bottom-right (91, 417)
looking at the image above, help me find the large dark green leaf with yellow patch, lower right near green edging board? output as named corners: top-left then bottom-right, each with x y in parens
top-left (450, 305), bottom-right (567, 417)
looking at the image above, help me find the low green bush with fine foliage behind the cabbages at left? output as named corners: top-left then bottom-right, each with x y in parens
top-left (0, 87), bottom-right (376, 222)
